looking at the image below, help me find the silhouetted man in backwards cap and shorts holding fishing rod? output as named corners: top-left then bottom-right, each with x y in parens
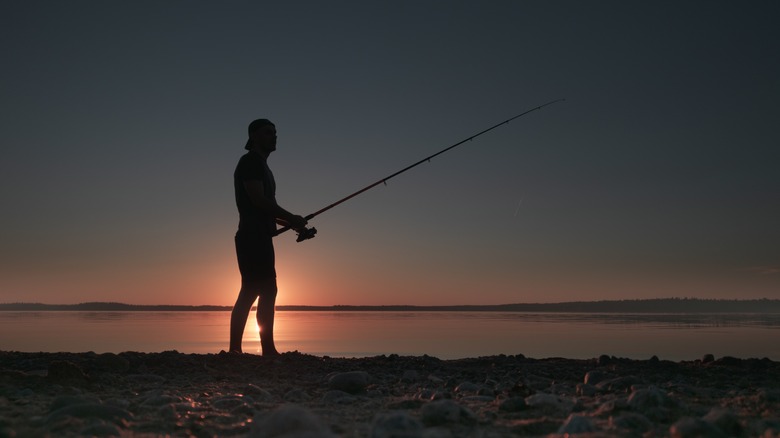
top-left (230, 119), bottom-right (306, 356)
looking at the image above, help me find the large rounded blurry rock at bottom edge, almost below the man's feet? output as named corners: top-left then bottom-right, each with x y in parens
top-left (249, 405), bottom-right (335, 438)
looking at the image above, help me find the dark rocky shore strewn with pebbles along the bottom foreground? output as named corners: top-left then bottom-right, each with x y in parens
top-left (0, 351), bottom-right (780, 438)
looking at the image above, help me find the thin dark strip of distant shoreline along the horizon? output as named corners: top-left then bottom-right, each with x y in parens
top-left (0, 298), bottom-right (780, 313)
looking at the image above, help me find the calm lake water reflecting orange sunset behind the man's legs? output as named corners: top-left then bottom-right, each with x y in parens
top-left (0, 311), bottom-right (780, 361)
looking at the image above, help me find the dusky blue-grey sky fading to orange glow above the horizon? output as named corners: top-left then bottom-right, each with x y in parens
top-left (0, 0), bottom-right (780, 305)
